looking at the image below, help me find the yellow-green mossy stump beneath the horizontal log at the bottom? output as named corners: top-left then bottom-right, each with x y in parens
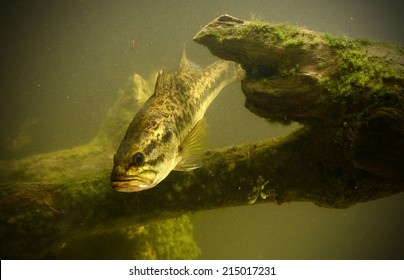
top-left (60, 215), bottom-right (201, 260)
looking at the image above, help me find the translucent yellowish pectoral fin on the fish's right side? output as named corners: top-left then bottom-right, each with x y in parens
top-left (174, 119), bottom-right (207, 171)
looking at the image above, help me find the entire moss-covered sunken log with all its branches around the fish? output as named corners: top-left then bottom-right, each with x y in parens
top-left (0, 15), bottom-right (404, 258)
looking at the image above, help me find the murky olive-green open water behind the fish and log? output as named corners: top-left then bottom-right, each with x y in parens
top-left (0, 0), bottom-right (404, 259)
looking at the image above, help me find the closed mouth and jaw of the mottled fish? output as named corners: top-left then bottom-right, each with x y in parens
top-left (110, 167), bottom-right (159, 192)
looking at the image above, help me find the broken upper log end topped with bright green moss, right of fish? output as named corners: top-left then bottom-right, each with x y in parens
top-left (194, 15), bottom-right (404, 123)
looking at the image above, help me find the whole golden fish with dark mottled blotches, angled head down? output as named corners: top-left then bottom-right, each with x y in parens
top-left (111, 51), bottom-right (243, 192)
